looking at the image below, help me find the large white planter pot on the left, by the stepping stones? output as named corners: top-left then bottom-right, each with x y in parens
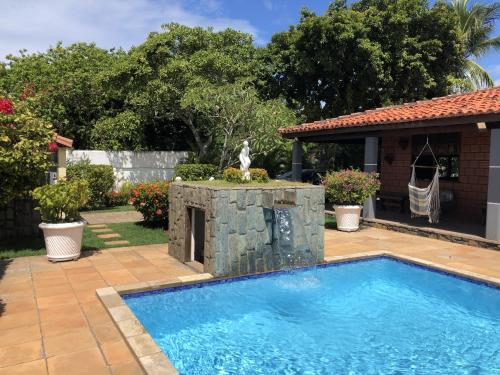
top-left (39, 221), bottom-right (86, 262)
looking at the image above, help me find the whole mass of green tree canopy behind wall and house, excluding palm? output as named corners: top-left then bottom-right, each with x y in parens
top-left (0, 0), bottom-right (480, 175)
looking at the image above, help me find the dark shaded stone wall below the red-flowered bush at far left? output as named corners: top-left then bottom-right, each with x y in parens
top-left (0, 199), bottom-right (41, 241)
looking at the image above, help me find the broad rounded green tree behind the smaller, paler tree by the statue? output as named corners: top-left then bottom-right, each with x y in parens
top-left (105, 23), bottom-right (262, 160)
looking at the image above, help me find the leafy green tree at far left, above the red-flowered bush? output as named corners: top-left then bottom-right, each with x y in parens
top-left (0, 43), bottom-right (119, 148)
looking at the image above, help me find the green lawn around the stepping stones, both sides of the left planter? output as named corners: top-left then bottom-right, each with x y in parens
top-left (0, 222), bottom-right (168, 259)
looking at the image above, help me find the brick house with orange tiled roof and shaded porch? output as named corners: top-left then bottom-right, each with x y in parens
top-left (280, 87), bottom-right (500, 241)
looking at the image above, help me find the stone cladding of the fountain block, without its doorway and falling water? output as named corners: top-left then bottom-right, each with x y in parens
top-left (169, 183), bottom-right (325, 276)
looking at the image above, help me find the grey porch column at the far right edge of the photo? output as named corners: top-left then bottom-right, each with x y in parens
top-left (486, 129), bottom-right (500, 241)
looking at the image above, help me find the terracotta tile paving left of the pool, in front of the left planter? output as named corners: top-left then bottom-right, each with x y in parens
top-left (0, 245), bottom-right (196, 375)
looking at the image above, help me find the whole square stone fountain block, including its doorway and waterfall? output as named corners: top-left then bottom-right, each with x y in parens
top-left (169, 182), bottom-right (325, 277)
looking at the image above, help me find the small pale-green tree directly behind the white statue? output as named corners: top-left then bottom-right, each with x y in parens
top-left (181, 81), bottom-right (297, 170)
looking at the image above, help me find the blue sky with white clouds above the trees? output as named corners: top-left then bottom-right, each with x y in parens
top-left (0, 0), bottom-right (500, 85)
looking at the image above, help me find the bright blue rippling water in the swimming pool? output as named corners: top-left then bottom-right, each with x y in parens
top-left (125, 258), bottom-right (500, 375)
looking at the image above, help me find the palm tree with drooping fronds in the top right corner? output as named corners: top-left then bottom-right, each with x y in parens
top-left (451, 0), bottom-right (500, 89)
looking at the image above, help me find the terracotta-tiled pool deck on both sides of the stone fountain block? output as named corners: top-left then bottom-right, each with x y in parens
top-left (0, 228), bottom-right (500, 375)
